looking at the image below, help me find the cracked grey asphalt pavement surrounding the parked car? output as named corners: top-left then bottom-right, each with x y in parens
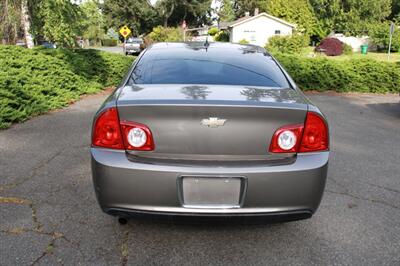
top-left (0, 91), bottom-right (400, 265)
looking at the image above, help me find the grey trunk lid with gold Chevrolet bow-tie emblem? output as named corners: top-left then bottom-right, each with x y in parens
top-left (117, 85), bottom-right (307, 160)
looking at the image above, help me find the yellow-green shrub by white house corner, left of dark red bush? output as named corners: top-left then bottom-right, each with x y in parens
top-left (265, 34), bottom-right (310, 54)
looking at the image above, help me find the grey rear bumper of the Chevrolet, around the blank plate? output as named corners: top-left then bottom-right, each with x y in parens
top-left (91, 148), bottom-right (329, 220)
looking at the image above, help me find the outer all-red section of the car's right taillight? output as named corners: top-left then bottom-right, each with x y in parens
top-left (299, 112), bottom-right (329, 152)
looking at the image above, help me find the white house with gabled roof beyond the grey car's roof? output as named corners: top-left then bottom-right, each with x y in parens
top-left (219, 13), bottom-right (295, 46)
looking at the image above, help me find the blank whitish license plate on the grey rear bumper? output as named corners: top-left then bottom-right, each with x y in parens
top-left (182, 177), bottom-right (242, 208)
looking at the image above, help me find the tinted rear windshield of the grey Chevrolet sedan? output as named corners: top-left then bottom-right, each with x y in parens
top-left (130, 50), bottom-right (289, 88)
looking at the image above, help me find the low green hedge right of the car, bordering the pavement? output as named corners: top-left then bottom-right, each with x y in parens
top-left (275, 54), bottom-right (400, 93)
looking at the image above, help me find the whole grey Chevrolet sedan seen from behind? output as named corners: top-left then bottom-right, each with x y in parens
top-left (91, 42), bottom-right (329, 223)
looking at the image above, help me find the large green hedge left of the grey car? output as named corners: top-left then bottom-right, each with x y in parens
top-left (0, 45), bottom-right (132, 128)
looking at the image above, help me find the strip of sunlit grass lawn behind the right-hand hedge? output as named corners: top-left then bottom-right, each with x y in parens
top-left (302, 47), bottom-right (400, 62)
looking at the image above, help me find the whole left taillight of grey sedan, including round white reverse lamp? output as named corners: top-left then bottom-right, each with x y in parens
top-left (92, 107), bottom-right (154, 151)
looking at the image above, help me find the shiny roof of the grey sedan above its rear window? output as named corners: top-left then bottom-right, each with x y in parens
top-left (146, 42), bottom-right (270, 59)
